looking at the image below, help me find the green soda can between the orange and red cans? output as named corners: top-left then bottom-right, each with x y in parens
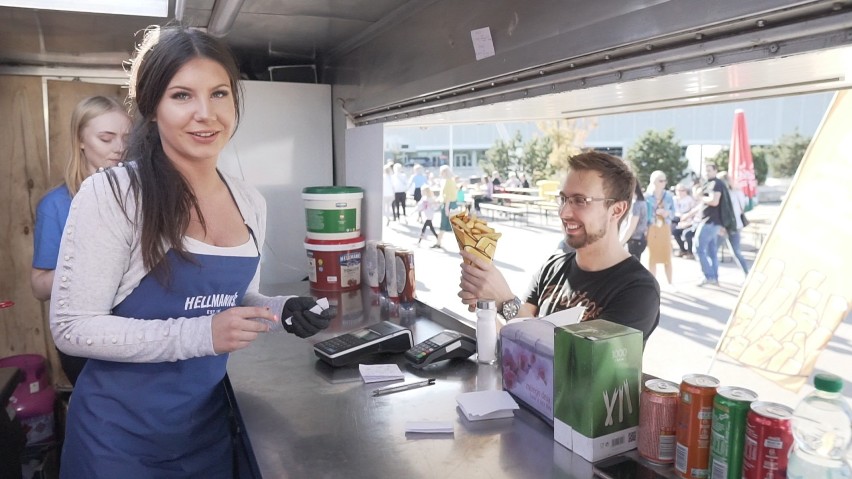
top-left (710, 387), bottom-right (757, 479)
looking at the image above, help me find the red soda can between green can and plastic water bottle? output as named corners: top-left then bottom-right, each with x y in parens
top-left (742, 401), bottom-right (793, 479)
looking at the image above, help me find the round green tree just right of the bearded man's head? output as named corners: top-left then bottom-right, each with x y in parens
top-left (626, 128), bottom-right (688, 188)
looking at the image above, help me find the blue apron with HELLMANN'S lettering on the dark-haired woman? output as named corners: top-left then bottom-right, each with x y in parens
top-left (61, 244), bottom-right (260, 479)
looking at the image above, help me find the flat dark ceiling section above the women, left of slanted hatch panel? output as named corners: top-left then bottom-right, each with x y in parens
top-left (0, 0), bottom-right (424, 80)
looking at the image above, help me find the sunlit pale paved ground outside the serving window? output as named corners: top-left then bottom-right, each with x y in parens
top-left (382, 203), bottom-right (852, 406)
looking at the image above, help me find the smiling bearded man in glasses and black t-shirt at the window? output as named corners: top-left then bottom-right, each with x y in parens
top-left (459, 152), bottom-right (660, 341)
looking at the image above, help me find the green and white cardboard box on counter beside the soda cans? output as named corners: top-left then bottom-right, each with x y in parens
top-left (553, 319), bottom-right (642, 461)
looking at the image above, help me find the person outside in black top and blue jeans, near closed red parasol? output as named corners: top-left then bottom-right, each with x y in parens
top-left (695, 163), bottom-right (725, 286)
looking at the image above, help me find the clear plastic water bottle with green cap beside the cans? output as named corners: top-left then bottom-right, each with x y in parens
top-left (787, 374), bottom-right (852, 479)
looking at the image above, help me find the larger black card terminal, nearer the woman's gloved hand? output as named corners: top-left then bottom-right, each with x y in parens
top-left (314, 321), bottom-right (413, 367)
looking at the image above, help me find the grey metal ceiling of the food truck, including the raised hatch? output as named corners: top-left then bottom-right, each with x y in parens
top-left (0, 0), bottom-right (852, 124)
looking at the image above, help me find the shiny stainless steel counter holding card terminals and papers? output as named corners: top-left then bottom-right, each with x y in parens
top-left (228, 284), bottom-right (672, 479)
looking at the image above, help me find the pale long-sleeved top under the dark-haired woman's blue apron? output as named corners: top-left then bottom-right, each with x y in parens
top-left (50, 167), bottom-right (290, 362)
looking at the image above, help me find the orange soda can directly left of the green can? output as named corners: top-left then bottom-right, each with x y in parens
top-left (675, 374), bottom-right (719, 479)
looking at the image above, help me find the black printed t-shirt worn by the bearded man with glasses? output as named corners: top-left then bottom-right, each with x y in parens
top-left (526, 252), bottom-right (660, 341)
